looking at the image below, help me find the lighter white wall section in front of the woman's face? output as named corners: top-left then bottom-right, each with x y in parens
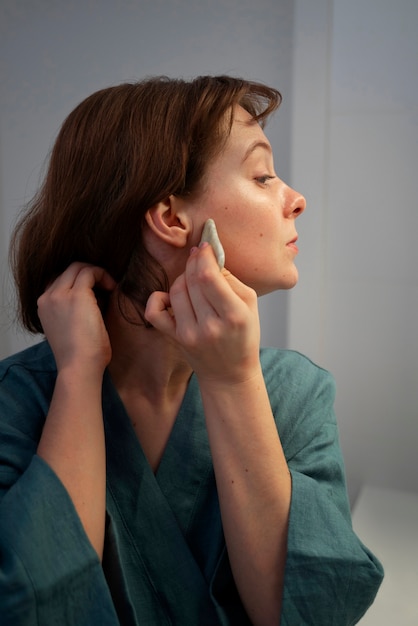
top-left (289, 0), bottom-right (418, 499)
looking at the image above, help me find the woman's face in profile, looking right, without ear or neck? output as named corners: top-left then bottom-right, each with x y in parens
top-left (188, 107), bottom-right (306, 295)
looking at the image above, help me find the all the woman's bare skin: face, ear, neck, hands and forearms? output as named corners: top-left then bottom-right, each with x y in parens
top-left (38, 107), bottom-right (305, 626)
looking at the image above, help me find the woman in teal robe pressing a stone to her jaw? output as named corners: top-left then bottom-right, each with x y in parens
top-left (0, 76), bottom-right (382, 626)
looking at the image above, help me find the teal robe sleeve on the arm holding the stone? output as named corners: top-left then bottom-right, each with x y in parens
top-left (262, 346), bottom-right (383, 626)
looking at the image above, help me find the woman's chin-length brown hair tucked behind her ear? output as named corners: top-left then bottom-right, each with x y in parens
top-left (10, 76), bottom-right (281, 332)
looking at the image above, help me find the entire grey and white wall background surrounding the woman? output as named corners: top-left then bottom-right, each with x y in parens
top-left (0, 0), bottom-right (418, 510)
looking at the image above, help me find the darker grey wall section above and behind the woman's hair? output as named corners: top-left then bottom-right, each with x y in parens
top-left (0, 0), bottom-right (293, 357)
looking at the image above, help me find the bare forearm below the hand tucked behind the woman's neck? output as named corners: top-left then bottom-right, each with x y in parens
top-left (37, 371), bottom-right (106, 558)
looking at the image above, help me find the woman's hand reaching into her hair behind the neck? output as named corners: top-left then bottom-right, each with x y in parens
top-left (38, 262), bottom-right (116, 376)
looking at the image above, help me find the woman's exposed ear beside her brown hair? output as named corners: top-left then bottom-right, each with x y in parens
top-left (145, 196), bottom-right (192, 248)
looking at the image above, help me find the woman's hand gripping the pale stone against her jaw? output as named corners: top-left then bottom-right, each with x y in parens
top-left (145, 244), bottom-right (260, 384)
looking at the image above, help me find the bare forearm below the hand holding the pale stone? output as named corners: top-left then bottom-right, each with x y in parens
top-left (201, 368), bottom-right (291, 626)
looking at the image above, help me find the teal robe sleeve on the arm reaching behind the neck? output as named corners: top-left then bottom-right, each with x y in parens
top-left (0, 354), bottom-right (119, 626)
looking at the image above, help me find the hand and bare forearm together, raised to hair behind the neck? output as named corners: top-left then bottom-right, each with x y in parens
top-left (37, 263), bottom-right (116, 557)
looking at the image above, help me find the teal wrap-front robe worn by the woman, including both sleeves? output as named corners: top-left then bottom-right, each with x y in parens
top-left (0, 342), bottom-right (383, 626)
